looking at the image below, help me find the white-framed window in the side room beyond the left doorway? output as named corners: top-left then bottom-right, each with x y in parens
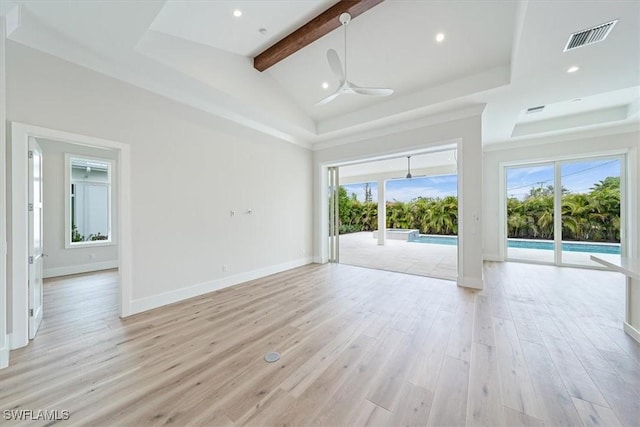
top-left (65, 154), bottom-right (112, 248)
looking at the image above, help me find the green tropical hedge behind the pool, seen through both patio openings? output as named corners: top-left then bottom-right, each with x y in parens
top-left (339, 177), bottom-right (620, 242)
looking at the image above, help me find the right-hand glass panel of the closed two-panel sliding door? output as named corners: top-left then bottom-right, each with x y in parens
top-left (559, 158), bottom-right (622, 267)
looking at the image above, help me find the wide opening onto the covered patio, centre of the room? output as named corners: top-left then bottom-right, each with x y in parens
top-left (328, 148), bottom-right (458, 280)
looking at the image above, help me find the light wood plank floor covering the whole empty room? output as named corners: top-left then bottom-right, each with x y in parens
top-left (0, 263), bottom-right (640, 426)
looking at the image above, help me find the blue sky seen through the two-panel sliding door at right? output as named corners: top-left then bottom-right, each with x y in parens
top-left (507, 159), bottom-right (620, 200)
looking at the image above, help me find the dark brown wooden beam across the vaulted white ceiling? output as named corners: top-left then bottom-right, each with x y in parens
top-left (253, 0), bottom-right (384, 71)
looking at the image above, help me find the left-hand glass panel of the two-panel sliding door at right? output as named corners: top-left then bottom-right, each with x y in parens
top-left (506, 164), bottom-right (555, 263)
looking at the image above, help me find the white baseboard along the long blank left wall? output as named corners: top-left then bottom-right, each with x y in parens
top-left (131, 257), bottom-right (313, 314)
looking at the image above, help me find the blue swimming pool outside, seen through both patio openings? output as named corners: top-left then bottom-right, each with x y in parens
top-left (409, 234), bottom-right (620, 254)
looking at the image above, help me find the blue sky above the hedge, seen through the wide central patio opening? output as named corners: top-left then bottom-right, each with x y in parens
top-left (343, 175), bottom-right (458, 202)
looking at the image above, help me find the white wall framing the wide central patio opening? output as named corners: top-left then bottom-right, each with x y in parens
top-left (314, 105), bottom-right (484, 289)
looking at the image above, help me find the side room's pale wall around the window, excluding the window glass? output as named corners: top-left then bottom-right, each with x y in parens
top-left (38, 139), bottom-right (118, 277)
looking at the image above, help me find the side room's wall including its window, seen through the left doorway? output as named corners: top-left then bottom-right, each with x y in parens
top-left (37, 138), bottom-right (119, 278)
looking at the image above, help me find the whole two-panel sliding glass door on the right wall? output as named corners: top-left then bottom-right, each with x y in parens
top-left (505, 156), bottom-right (624, 266)
